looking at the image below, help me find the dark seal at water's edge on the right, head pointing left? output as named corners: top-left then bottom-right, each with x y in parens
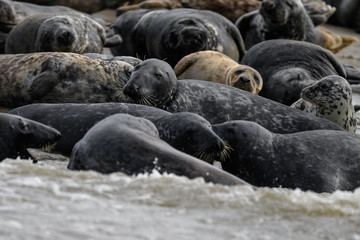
top-left (213, 121), bottom-right (360, 192)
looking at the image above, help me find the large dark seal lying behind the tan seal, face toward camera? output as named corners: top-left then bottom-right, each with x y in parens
top-left (111, 9), bottom-right (245, 66)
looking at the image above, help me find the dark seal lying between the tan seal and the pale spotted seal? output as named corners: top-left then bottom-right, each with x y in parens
top-left (242, 39), bottom-right (360, 105)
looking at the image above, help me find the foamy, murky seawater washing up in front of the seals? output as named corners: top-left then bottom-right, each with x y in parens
top-left (0, 151), bottom-right (360, 240)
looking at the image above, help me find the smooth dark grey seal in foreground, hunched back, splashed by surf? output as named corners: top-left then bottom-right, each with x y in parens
top-left (68, 114), bottom-right (246, 185)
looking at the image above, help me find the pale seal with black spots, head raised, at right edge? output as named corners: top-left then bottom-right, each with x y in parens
top-left (291, 76), bottom-right (356, 132)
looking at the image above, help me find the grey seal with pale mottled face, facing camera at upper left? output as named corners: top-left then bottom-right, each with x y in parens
top-left (5, 12), bottom-right (106, 54)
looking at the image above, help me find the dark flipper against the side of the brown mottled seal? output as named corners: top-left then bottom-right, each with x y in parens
top-left (29, 72), bottom-right (60, 100)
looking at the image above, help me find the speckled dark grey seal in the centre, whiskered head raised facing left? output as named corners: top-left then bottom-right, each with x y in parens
top-left (123, 59), bottom-right (343, 133)
